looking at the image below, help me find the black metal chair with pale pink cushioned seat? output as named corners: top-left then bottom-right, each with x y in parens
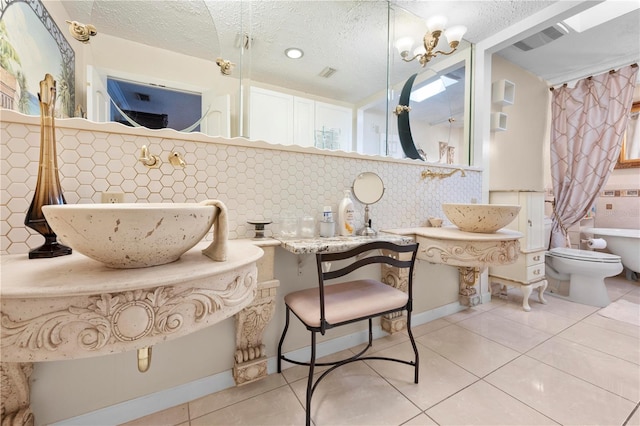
top-left (278, 241), bottom-right (419, 426)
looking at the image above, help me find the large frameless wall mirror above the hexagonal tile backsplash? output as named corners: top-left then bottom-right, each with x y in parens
top-left (62, 0), bottom-right (471, 165)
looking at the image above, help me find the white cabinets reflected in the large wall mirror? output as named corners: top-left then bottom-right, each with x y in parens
top-left (248, 86), bottom-right (353, 151)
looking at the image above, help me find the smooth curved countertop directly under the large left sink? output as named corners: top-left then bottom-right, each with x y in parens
top-left (0, 240), bottom-right (264, 299)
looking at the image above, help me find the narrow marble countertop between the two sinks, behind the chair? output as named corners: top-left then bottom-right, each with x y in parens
top-left (279, 232), bottom-right (413, 254)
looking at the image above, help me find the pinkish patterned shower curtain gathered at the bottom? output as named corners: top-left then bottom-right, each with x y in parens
top-left (550, 64), bottom-right (638, 248)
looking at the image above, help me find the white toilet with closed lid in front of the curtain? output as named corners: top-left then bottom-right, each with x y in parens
top-left (545, 218), bottom-right (623, 308)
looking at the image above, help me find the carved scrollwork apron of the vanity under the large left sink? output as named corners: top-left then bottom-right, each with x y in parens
top-left (1, 274), bottom-right (256, 351)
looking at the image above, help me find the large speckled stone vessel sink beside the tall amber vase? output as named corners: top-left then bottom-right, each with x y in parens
top-left (42, 203), bottom-right (226, 268)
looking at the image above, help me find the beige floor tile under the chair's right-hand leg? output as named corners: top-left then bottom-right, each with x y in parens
top-left (360, 344), bottom-right (478, 410)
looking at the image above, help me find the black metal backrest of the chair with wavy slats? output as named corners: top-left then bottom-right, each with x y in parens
top-left (316, 241), bottom-right (418, 332)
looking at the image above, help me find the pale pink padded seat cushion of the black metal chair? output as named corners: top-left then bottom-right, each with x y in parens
top-left (284, 280), bottom-right (409, 327)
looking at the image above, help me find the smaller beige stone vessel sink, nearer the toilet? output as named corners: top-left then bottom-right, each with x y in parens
top-left (442, 203), bottom-right (520, 234)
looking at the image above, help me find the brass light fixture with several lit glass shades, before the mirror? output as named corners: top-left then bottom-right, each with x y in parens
top-left (395, 16), bottom-right (467, 67)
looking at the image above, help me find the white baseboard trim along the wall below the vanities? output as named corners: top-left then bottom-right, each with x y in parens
top-left (51, 298), bottom-right (464, 426)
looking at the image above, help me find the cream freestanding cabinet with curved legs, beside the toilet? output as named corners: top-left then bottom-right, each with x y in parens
top-left (489, 191), bottom-right (547, 311)
